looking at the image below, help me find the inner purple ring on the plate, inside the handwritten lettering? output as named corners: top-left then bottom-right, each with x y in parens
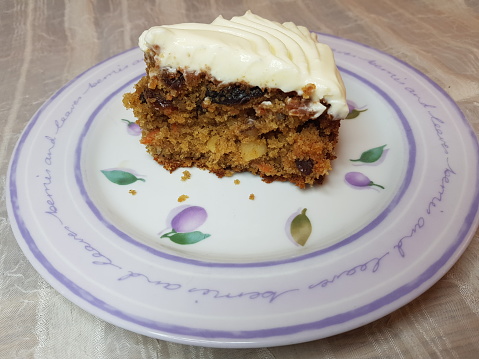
top-left (74, 64), bottom-right (416, 267)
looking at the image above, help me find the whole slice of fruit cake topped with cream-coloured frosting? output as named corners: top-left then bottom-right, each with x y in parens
top-left (123, 12), bottom-right (348, 188)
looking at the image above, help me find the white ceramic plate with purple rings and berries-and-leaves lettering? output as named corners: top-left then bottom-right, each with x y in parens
top-left (7, 35), bottom-right (479, 347)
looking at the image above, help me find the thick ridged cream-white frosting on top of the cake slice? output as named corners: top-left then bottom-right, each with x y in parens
top-left (139, 11), bottom-right (349, 119)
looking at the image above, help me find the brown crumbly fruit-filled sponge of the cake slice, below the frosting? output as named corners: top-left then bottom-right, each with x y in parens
top-left (124, 54), bottom-right (340, 188)
